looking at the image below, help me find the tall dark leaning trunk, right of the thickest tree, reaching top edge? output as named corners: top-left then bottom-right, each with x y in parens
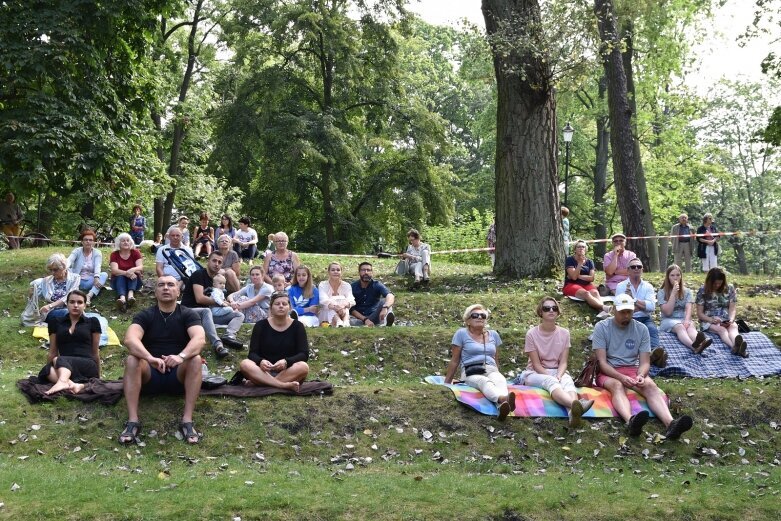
top-left (594, 0), bottom-right (649, 267)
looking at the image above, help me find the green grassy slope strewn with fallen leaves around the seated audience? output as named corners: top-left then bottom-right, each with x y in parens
top-left (0, 249), bottom-right (781, 520)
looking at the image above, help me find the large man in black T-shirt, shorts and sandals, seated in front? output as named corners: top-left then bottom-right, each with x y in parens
top-left (119, 275), bottom-right (206, 444)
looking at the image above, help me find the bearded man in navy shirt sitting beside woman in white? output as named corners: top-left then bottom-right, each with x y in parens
top-left (350, 262), bottom-right (396, 327)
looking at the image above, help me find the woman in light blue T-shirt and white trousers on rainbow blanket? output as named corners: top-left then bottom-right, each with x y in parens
top-left (445, 304), bottom-right (515, 420)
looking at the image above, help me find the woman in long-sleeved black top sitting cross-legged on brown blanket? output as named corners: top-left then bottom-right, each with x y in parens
top-left (239, 291), bottom-right (309, 392)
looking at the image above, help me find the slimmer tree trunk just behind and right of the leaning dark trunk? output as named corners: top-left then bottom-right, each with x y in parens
top-left (622, 20), bottom-right (656, 271)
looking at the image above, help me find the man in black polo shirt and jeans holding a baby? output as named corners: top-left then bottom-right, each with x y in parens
top-left (182, 251), bottom-right (244, 358)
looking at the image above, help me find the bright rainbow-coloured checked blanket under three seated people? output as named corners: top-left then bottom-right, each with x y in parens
top-left (425, 376), bottom-right (653, 418)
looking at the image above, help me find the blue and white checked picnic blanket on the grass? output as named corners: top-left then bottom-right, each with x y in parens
top-left (651, 331), bottom-right (781, 378)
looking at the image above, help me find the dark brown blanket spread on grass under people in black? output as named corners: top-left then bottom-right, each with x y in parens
top-left (16, 376), bottom-right (333, 405)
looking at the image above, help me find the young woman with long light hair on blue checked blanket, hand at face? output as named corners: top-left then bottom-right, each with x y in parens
top-left (656, 264), bottom-right (713, 355)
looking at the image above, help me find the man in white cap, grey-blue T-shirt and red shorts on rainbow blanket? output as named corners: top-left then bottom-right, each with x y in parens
top-left (592, 293), bottom-right (693, 440)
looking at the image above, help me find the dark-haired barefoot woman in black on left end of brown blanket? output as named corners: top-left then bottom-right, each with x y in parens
top-left (38, 289), bottom-right (100, 394)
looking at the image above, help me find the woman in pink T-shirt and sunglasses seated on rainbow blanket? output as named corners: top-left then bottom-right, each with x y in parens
top-left (515, 297), bottom-right (594, 427)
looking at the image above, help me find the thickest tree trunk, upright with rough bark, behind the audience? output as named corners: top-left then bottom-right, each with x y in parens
top-left (482, 0), bottom-right (564, 277)
